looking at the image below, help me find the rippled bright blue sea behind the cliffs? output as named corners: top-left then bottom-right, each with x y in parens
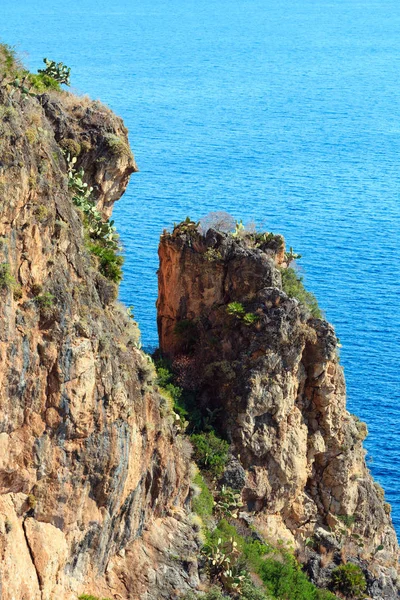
top-left (0, 0), bottom-right (400, 533)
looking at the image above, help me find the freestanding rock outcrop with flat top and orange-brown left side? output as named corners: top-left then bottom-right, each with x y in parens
top-left (158, 223), bottom-right (398, 598)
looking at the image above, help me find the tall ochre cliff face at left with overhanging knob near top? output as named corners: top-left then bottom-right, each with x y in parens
top-left (0, 61), bottom-right (197, 600)
